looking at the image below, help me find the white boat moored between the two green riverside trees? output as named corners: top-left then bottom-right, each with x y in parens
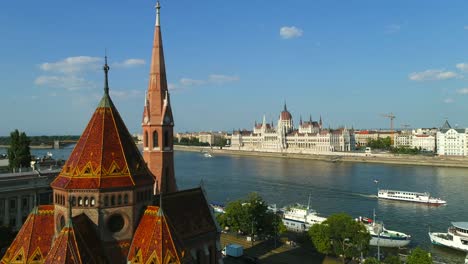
top-left (282, 196), bottom-right (327, 232)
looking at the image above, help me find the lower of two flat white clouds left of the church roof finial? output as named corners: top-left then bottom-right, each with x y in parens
top-left (34, 75), bottom-right (96, 91)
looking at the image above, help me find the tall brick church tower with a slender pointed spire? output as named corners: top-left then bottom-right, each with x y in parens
top-left (141, 2), bottom-right (177, 193)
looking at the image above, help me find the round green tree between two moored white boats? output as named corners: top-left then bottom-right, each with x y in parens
top-left (308, 213), bottom-right (371, 263)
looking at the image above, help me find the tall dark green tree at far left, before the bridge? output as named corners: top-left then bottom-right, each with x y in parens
top-left (8, 129), bottom-right (31, 171)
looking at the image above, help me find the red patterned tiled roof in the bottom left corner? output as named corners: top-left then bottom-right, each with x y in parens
top-left (1, 205), bottom-right (55, 264)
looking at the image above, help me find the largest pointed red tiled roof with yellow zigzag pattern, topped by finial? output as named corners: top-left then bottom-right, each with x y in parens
top-left (51, 94), bottom-right (154, 189)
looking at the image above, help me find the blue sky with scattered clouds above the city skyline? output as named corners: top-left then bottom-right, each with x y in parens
top-left (0, 0), bottom-right (468, 135)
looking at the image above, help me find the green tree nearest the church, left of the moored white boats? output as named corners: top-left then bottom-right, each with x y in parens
top-left (218, 193), bottom-right (286, 236)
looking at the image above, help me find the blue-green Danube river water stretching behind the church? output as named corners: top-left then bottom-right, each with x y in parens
top-left (0, 148), bottom-right (468, 263)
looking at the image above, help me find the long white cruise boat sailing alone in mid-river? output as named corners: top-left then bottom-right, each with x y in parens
top-left (377, 190), bottom-right (447, 205)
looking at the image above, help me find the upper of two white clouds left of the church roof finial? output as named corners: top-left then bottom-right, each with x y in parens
top-left (39, 56), bottom-right (103, 74)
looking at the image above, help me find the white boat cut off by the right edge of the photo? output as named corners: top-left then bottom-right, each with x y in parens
top-left (429, 222), bottom-right (468, 252)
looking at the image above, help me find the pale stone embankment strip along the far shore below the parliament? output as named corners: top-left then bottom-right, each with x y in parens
top-left (174, 145), bottom-right (468, 168)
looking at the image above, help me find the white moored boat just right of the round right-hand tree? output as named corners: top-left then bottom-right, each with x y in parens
top-left (358, 217), bottom-right (411, 248)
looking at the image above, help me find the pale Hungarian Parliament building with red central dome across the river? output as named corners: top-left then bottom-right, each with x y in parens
top-left (231, 104), bottom-right (356, 153)
